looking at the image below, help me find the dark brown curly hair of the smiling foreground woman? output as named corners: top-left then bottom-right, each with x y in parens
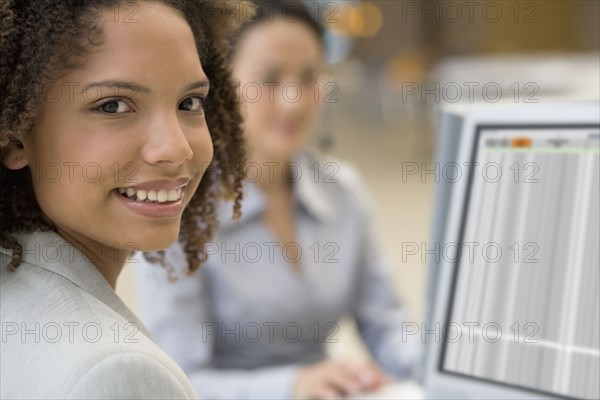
top-left (0, 0), bottom-right (254, 274)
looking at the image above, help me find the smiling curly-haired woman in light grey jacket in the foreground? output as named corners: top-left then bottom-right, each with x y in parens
top-left (0, 0), bottom-right (251, 399)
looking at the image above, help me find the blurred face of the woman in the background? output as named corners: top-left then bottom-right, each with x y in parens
top-left (233, 19), bottom-right (323, 159)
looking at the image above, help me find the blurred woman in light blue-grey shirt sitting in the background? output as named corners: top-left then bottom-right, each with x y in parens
top-left (139, 0), bottom-right (418, 399)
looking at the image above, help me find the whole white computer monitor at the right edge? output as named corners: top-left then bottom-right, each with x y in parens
top-left (421, 103), bottom-right (600, 399)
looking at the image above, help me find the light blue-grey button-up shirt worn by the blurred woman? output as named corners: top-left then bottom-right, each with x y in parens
top-left (137, 152), bottom-right (420, 399)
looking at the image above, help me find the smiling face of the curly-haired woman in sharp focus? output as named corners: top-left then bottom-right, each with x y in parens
top-left (12, 2), bottom-right (213, 251)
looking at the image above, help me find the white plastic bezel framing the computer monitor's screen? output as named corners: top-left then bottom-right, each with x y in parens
top-left (425, 103), bottom-right (600, 399)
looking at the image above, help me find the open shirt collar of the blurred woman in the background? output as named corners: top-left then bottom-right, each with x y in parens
top-left (219, 152), bottom-right (335, 229)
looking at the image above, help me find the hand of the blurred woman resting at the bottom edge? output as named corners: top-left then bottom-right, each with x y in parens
top-left (294, 360), bottom-right (389, 400)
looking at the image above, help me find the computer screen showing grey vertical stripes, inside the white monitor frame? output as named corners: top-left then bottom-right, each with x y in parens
top-left (438, 125), bottom-right (600, 398)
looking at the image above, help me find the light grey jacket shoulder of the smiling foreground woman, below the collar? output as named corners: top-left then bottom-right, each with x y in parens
top-left (0, 245), bottom-right (195, 398)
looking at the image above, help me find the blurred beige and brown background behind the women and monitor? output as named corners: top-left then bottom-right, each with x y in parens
top-left (118, 0), bottom-right (600, 358)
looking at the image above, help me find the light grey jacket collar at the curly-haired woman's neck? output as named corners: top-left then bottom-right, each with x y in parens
top-left (6, 231), bottom-right (152, 337)
